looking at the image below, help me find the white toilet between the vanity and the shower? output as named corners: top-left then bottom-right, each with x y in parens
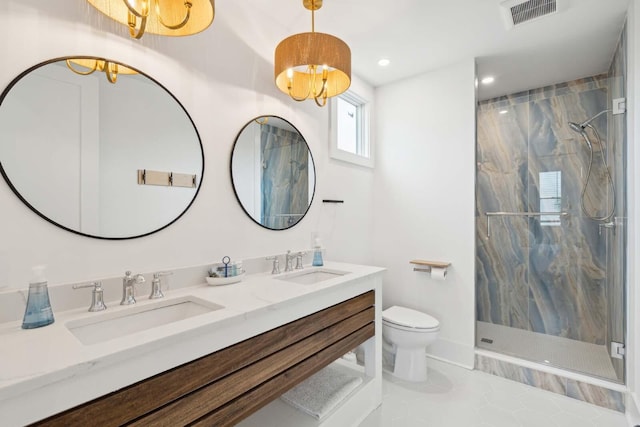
top-left (382, 305), bottom-right (440, 382)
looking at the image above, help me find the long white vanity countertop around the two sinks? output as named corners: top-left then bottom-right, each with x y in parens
top-left (0, 262), bottom-right (384, 425)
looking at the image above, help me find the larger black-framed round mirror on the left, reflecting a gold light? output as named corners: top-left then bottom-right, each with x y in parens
top-left (0, 57), bottom-right (204, 239)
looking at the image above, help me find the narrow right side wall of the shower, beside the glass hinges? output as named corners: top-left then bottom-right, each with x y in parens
top-left (606, 24), bottom-right (627, 380)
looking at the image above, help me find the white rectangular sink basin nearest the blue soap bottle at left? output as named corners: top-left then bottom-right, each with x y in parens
top-left (65, 296), bottom-right (224, 344)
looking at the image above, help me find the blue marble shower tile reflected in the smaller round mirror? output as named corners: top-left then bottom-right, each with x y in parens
top-left (260, 125), bottom-right (310, 229)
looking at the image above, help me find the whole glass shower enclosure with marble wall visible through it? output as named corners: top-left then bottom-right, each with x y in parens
top-left (476, 44), bottom-right (626, 382)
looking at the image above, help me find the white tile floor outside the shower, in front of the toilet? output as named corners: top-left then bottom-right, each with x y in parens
top-left (360, 359), bottom-right (627, 427)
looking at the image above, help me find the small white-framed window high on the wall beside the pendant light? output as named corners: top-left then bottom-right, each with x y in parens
top-left (329, 91), bottom-right (373, 167)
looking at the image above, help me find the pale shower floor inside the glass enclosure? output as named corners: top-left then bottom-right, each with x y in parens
top-left (476, 321), bottom-right (618, 381)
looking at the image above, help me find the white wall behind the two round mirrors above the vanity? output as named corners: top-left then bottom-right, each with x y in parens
top-left (0, 0), bottom-right (373, 288)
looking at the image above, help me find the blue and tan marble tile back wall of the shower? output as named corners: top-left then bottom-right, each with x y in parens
top-left (476, 75), bottom-right (611, 348)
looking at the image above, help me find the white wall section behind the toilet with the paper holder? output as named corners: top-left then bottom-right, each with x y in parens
top-left (374, 60), bottom-right (475, 367)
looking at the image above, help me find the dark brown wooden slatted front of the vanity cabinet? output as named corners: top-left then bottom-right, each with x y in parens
top-left (33, 291), bottom-right (375, 427)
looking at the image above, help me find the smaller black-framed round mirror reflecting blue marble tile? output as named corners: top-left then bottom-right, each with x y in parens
top-left (231, 116), bottom-right (316, 230)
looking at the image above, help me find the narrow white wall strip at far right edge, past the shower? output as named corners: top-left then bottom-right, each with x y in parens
top-left (626, 0), bottom-right (640, 423)
